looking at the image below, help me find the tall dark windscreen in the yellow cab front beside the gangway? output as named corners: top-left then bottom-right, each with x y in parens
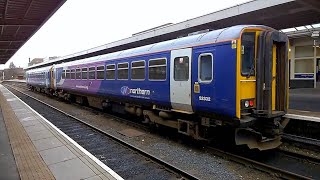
top-left (241, 32), bottom-right (255, 76)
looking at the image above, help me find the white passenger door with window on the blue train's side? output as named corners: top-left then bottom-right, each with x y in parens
top-left (170, 48), bottom-right (193, 112)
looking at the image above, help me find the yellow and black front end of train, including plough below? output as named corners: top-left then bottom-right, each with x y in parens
top-left (235, 28), bottom-right (289, 150)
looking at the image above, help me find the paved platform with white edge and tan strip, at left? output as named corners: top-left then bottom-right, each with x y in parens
top-left (0, 84), bottom-right (122, 180)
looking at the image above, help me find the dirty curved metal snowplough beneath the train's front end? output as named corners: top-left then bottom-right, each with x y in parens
top-left (235, 128), bottom-right (282, 151)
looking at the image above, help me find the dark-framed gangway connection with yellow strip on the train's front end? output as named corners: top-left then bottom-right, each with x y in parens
top-left (256, 31), bottom-right (288, 118)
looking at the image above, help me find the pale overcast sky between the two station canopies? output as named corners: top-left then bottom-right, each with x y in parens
top-left (1, 0), bottom-right (249, 68)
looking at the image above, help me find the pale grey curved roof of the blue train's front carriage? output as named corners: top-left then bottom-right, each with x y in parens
top-left (37, 25), bottom-right (274, 67)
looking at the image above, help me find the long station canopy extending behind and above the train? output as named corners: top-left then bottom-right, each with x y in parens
top-left (27, 0), bottom-right (320, 69)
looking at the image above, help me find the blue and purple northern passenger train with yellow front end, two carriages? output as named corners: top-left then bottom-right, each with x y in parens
top-left (26, 25), bottom-right (289, 150)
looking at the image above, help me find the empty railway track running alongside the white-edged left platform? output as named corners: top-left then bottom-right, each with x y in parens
top-left (7, 86), bottom-right (199, 179)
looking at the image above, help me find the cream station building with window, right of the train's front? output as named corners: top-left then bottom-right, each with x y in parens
top-left (283, 27), bottom-right (320, 88)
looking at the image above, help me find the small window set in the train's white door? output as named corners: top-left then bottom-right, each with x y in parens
top-left (173, 56), bottom-right (189, 81)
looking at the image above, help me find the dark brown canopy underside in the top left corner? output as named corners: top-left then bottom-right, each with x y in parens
top-left (0, 0), bottom-right (66, 64)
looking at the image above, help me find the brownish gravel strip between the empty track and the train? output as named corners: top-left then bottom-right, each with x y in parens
top-left (8, 84), bottom-right (275, 179)
